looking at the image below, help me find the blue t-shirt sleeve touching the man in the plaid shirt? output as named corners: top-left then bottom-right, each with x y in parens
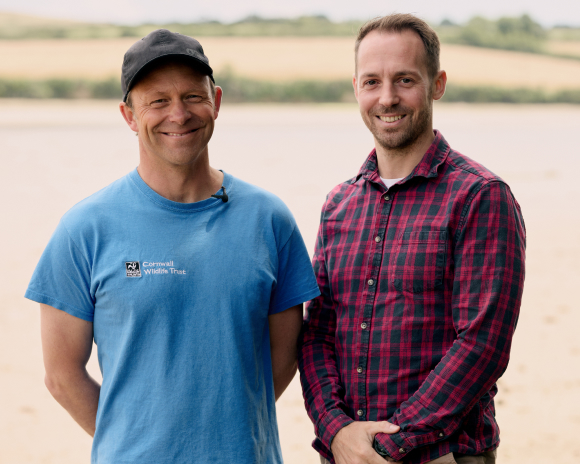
top-left (268, 225), bottom-right (320, 314)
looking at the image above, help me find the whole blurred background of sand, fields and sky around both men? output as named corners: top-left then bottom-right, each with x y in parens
top-left (0, 0), bottom-right (580, 464)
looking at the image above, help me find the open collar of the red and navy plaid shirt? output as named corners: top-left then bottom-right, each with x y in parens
top-left (354, 130), bottom-right (450, 185)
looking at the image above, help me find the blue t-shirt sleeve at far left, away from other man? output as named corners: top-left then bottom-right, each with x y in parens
top-left (25, 221), bottom-right (95, 321)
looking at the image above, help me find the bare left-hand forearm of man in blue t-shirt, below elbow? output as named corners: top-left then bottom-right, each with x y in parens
top-left (45, 370), bottom-right (101, 436)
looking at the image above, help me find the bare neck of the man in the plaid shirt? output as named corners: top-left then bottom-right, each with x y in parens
top-left (375, 128), bottom-right (435, 179)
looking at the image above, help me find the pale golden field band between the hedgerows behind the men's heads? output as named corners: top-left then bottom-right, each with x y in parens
top-left (0, 37), bottom-right (580, 91)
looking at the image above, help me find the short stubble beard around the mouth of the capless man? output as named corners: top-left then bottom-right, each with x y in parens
top-left (365, 102), bottom-right (432, 155)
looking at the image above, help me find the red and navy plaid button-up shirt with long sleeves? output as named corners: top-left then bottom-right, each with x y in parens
top-left (299, 131), bottom-right (525, 464)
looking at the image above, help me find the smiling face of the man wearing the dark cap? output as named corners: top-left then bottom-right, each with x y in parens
top-left (124, 62), bottom-right (221, 166)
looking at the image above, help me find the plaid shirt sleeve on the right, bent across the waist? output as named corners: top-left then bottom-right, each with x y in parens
top-left (376, 181), bottom-right (525, 461)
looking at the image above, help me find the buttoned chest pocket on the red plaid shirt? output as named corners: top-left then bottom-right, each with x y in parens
top-left (392, 230), bottom-right (447, 293)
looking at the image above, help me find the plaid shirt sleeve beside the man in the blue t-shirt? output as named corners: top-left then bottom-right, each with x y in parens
top-left (298, 200), bottom-right (353, 457)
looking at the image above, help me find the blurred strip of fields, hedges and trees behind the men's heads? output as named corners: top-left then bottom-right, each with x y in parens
top-left (0, 13), bottom-right (580, 104)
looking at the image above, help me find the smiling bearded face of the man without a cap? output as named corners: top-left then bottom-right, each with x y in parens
top-left (353, 30), bottom-right (444, 156)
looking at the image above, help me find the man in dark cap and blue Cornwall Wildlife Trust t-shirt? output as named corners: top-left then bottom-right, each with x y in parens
top-left (26, 30), bottom-right (319, 464)
